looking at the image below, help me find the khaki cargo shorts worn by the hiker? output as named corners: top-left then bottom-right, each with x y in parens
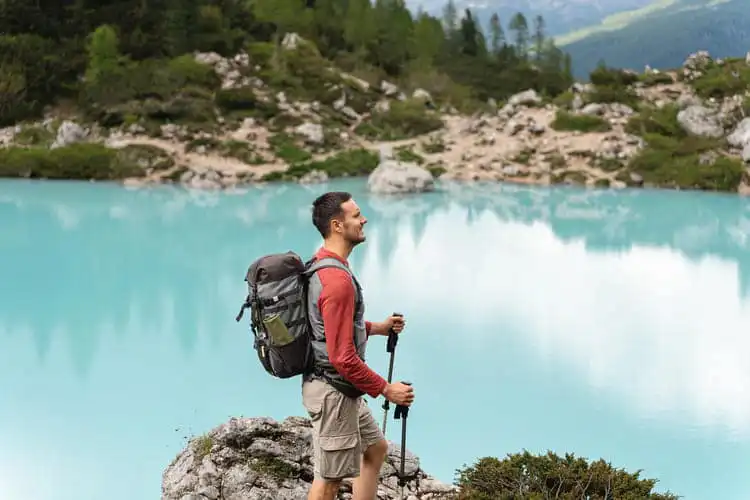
top-left (302, 379), bottom-right (383, 481)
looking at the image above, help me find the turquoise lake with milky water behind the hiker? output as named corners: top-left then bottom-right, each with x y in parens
top-left (0, 180), bottom-right (750, 500)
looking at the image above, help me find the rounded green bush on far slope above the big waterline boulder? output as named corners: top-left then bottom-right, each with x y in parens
top-left (356, 101), bottom-right (444, 141)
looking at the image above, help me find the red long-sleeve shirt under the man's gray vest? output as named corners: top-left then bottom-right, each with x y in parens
top-left (315, 248), bottom-right (386, 397)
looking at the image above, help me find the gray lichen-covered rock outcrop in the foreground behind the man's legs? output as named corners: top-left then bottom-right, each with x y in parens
top-left (161, 417), bottom-right (458, 500)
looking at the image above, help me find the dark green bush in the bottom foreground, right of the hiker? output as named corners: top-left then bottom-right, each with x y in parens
top-left (456, 451), bottom-right (678, 500)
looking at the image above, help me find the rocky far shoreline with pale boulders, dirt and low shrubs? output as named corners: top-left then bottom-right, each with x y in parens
top-left (0, 44), bottom-right (750, 194)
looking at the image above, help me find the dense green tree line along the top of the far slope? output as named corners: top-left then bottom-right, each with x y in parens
top-left (0, 0), bottom-right (572, 125)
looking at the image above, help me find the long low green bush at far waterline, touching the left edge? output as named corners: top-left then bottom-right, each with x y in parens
top-left (0, 143), bottom-right (145, 180)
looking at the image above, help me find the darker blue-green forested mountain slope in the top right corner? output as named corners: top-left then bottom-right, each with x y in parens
top-left (557, 0), bottom-right (750, 78)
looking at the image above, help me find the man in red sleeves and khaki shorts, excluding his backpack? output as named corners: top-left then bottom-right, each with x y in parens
top-left (302, 192), bottom-right (414, 500)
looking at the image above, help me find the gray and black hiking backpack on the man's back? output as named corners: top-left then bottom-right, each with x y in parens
top-left (235, 251), bottom-right (346, 378)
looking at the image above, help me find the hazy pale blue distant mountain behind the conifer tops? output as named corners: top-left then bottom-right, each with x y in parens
top-left (406, 0), bottom-right (660, 35)
